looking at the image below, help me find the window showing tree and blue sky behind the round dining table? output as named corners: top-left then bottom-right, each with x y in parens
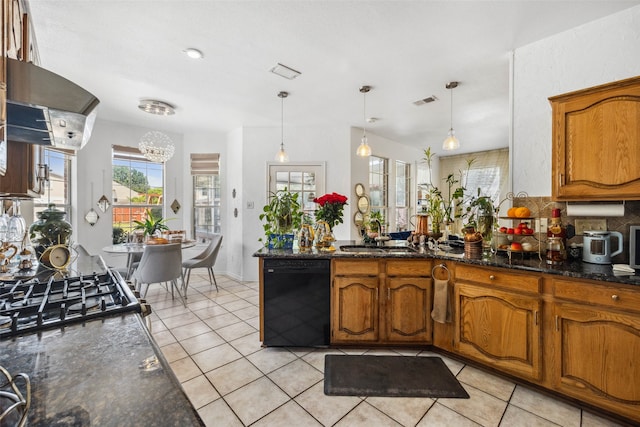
top-left (112, 145), bottom-right (164, 233)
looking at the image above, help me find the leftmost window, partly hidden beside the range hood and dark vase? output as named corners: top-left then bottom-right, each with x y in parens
top-left (33, 148), bottom-right (71, 222)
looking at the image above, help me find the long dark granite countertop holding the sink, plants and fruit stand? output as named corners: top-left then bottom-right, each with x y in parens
top-left (253, 240), bottom-right (640, 289)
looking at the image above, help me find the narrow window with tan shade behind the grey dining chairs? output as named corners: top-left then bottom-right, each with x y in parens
top-left (191, 153), bottom-right (222, 236)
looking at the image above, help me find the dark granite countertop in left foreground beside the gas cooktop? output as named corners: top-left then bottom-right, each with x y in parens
top-left (0, 314), bottom-right (204, 427)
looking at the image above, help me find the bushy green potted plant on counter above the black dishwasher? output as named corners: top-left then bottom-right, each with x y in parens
top-left (259, 187), bottom-right (302, 249)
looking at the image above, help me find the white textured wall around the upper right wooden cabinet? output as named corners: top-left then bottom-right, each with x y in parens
top-left (512, 6), bottom-right (640, 196)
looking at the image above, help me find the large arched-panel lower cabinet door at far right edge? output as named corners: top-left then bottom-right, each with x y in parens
top-left (554, 304), bottom-right (640, 421)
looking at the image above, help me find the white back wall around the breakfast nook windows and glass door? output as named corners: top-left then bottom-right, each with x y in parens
top-left (72, 119), bottom-right (422, 281)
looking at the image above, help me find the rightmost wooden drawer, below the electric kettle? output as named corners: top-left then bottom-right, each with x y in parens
top-left (553, 279), bottom-right (640, 311)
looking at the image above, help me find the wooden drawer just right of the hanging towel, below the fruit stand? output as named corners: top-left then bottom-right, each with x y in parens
top-left (456, 264), bottom-right (542, 293)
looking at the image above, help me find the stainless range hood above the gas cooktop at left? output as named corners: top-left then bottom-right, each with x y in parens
top-left (6, 58), bottom-right (100, 150)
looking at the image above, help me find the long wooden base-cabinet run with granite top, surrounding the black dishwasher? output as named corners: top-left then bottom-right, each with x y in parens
top-left (254, 241), bottom-right (640, 424)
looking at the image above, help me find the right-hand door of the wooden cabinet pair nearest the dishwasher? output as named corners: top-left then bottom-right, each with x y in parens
top-left (384, 277), bottom-right (432, 344)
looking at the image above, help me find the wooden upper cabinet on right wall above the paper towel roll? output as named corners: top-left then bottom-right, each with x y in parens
top-left (549, 76), bottom-right (640, 201)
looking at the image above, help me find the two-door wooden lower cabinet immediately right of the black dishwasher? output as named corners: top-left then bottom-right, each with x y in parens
top-left (331, 260), bottom-right (432, 345)
